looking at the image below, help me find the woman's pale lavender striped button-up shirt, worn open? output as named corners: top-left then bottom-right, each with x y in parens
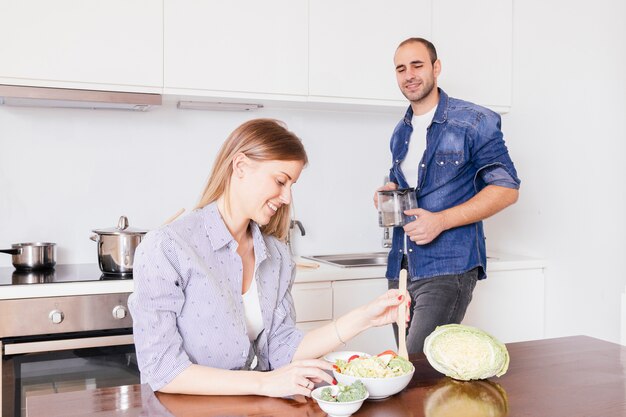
top-left (128, 203), bottom-right (303, 391)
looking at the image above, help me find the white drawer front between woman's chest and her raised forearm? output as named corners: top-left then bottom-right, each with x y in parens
top-left (291, 282), bottom-right (333, 323)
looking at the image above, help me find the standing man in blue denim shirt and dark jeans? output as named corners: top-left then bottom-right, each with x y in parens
top-left (374, 38), bottom-right (520, 353)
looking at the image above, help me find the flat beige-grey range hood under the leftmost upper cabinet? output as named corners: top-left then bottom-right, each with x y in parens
top-left (0, 84), bottom-right (162, 111)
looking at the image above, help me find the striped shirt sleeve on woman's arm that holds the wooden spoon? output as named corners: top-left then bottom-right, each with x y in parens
top-left (267, 267), bottom-right (304, 369)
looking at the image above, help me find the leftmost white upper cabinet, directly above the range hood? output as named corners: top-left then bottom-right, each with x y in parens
top-left (0, 0), bottom-right (163, 92)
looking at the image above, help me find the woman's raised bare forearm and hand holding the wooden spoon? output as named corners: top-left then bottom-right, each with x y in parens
top-left (293, 290), bottom-right (409, 360)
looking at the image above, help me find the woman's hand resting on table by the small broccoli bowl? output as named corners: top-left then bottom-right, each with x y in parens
top-left (260, 359), bottom-right (337, 397)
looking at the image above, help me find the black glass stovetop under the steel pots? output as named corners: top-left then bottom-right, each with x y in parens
top-left (0, 264), bottom-right (133, 286)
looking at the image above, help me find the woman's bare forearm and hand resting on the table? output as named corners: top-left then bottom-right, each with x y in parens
top-left (159, 359), bottom-right (334, 397)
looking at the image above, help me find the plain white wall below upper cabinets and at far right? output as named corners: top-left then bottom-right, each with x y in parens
top-left (0, 0), bottom-right (626, 341)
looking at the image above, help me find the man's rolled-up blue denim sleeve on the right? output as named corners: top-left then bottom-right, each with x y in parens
top-left (472, 109), bottom-right (521, 191)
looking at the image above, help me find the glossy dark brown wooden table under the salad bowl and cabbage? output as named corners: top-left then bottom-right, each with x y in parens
top-left (26, 336), bottom-right (626, 417)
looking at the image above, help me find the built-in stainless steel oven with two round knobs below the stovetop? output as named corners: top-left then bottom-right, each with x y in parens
top-left (0, 266), bottom-right (140, 417)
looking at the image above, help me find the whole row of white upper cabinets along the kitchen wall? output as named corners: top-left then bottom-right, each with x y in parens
top-left (0, 0), bottom-right (512, 111)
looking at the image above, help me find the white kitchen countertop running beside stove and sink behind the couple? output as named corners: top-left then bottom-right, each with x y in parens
top-left (0, 253), bottom-right (545, 300)
